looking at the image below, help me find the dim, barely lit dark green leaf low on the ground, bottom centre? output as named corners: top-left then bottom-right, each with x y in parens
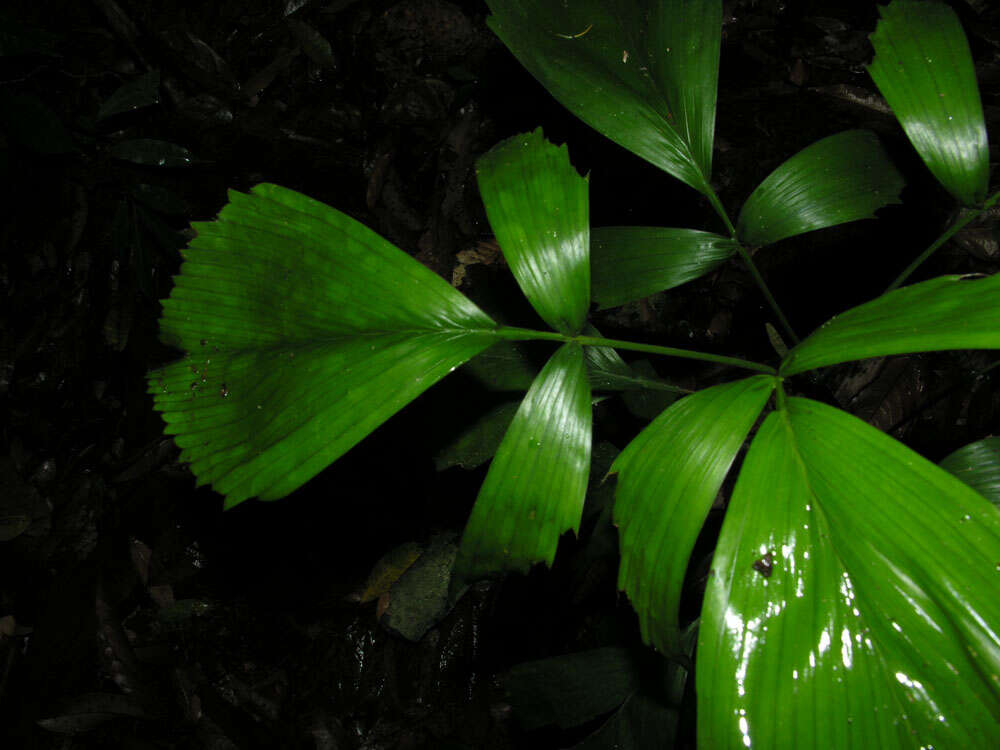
top-left (503, 647), bottom-right (648, 730)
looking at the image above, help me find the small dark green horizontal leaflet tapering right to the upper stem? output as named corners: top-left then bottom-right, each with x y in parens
top-left (590, 227), bottom-right (736, 310)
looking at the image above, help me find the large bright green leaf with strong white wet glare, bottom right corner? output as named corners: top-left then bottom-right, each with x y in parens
top-left (697, 398), bottom-right (1000, 749)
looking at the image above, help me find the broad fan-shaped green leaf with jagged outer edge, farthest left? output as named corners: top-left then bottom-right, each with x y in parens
top-left (149, 184), bottom-right (496, 507)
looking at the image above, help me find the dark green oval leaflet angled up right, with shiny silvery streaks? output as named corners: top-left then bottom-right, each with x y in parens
top-left (736, 130), bottom-right (903, 247)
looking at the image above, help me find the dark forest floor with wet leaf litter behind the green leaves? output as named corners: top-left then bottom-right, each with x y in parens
top-left (0, 0), bottom-right (1000, 750)
